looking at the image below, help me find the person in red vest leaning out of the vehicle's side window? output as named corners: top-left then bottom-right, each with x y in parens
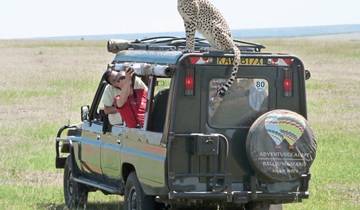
top-left (104, 68), bottom-right (148, 128)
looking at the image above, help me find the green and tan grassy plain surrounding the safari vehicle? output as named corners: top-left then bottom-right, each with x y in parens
top-left (0, 36), bottom-right (360, 210)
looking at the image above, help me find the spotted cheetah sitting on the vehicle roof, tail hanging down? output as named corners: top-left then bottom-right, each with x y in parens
top-left (178, 0), bottom-right (241, 97)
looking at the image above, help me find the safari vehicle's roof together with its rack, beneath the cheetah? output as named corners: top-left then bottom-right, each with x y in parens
top-left (108, 36), bottom-right (265, 65)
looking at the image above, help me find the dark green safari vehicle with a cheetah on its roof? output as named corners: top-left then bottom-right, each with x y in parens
top-left (55, 37), bottom-right (316, 210)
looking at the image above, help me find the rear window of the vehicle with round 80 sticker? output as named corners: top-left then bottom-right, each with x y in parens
top-left (208, 78), bottom-right (269, 128)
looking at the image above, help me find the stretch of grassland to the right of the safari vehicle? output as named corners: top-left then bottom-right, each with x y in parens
top-left (265, 39), bottom-right (360, 210)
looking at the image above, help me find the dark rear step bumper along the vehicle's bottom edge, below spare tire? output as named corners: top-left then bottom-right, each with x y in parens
top-left (169, 191), bottom-right (309, 203)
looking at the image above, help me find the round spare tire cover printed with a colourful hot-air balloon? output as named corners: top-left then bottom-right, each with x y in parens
top-left (246, 110), bottom-right (316, 181)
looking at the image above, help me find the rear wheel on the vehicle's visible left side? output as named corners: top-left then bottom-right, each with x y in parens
top-left (124, 172), bottom-right (156, 210)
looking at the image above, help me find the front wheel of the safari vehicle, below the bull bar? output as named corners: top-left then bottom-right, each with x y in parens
top-left (64, 155), bottom-right (88, 209)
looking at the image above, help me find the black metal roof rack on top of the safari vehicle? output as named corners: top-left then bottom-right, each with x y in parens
top-left (109, 36), bottom-right (265, 52)
